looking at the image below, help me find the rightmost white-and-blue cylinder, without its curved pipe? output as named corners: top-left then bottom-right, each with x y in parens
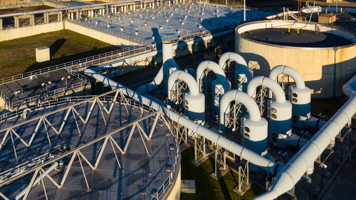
top-left (289, 86), bottom-right (311, 128)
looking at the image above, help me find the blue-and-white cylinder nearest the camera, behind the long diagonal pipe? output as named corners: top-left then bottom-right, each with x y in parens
top-left (242, 117), bottom-right (268, 171)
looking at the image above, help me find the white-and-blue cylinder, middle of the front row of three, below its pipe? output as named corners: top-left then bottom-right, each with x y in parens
top-left (268, 100), bottom-right (292, 148)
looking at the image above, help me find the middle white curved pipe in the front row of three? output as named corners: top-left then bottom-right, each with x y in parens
top-left (247, 76), bottom-right (286, 103)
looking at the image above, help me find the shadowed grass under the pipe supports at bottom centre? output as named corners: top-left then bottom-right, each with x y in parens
top-left (180, 147), bottom-right (265, 200)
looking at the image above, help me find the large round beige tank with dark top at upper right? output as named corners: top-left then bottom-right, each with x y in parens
top-left (235, 20), bottom-right (356, 98)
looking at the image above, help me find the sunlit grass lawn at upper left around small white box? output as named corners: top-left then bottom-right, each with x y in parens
top-left (0, 30), bottom-right (119, 78)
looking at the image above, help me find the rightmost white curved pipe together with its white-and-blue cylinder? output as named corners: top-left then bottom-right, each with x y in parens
top-left (269, 65), bottom-right (311, 128)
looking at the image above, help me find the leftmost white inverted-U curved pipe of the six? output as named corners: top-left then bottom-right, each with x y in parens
top-left (168, 70), bottom-right (199, 100)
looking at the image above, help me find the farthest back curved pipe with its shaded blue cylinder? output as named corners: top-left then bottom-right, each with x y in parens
top-left (219, 52), bottom-right (252, 92)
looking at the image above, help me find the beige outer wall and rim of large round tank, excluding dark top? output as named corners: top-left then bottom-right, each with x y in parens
top-left (235, 20), bottom-right (356, 98)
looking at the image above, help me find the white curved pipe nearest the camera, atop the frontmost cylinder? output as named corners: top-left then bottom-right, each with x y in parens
top-left (219, 90), bottom-right (261, 125)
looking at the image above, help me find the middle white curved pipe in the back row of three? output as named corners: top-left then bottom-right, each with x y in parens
top-left (196, 61), bottom-right (226, 90)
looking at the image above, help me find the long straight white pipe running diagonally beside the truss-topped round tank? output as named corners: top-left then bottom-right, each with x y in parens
top-left (84, 69), bottom-right (280, 174)
